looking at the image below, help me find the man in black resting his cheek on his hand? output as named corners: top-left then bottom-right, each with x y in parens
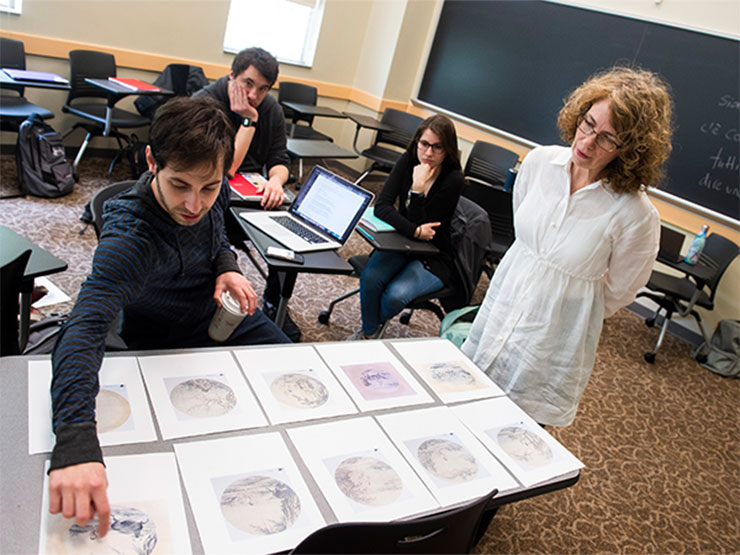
top-left (195, 48), bottom-right (301, 341)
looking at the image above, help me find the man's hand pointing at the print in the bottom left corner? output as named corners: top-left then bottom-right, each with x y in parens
top-left (49, 462), bottom-right (110, 538)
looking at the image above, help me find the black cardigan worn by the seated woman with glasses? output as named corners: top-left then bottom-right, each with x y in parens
top-left (375, 151), bottom-right (465, 283)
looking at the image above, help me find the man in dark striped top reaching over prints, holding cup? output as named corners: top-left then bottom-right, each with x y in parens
top-left (49, 97), bottom-right (289, 536)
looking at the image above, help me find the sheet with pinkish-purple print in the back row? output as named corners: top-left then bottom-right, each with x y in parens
top-left (316, 341), bottom-right (432, 411)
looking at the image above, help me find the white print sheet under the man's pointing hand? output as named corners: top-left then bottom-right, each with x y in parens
top-left (39, 453), bottom-right (192, 555)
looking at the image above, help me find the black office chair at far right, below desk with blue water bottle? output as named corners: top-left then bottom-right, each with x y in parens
top-left (637, 233), bottom-right (740, 364)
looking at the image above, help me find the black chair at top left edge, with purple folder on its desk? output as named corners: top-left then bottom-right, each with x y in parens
top-left (0, 37), bottom-right (54, 133)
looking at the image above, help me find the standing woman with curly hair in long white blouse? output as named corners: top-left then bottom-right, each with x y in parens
top-left (462, 67), bottom-right (672, 426)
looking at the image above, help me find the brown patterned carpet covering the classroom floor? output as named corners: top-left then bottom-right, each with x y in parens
top-left (0, 157), bottom-right (740, 553)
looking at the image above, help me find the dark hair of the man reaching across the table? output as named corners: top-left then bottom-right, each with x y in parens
top-left (149, 95), bottom-right (234, 173)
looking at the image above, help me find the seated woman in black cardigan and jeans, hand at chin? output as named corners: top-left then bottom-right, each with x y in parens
top-left (349, 115), bottom-right (465, 340)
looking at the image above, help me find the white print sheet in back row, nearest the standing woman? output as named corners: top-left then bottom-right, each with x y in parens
top-left (392, 338), bottom-right (504, 403)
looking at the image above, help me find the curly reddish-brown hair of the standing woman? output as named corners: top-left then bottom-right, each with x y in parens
top-left (558, 67), bottom-right (673, 193)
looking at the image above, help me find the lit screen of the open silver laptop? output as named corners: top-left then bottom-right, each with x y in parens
top-left (290, 166), bottom-right (373, 243)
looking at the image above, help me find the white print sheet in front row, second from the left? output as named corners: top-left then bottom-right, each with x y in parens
top-left (175, 433), bottom-right (325, 553)
